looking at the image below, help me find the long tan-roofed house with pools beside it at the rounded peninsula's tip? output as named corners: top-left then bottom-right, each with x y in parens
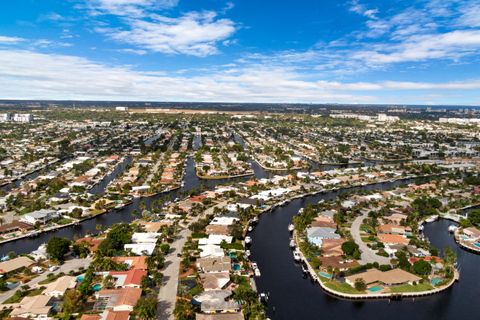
top-left (345, 269), bottom-right (422, 287)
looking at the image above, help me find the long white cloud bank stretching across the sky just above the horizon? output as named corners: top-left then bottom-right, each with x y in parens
top-left (0, 50), bottom-right (480, 103)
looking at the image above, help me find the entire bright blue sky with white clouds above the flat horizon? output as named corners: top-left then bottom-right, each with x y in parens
top-left (0, 0), bottom-right (480, 105)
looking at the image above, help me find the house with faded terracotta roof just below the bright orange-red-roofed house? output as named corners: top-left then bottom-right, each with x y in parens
top-left (95, 288), bottom-right (142, 311)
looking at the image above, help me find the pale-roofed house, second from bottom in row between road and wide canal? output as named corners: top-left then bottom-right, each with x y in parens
top-left (192, 290), bottom-right (240, 313)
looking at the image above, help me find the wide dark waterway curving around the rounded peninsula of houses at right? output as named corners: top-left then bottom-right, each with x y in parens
top-left (251, 182), bottom-right (480, 320)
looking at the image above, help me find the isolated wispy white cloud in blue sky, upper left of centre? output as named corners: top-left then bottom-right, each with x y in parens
top-left (96, 11), bottom-right (235, 57)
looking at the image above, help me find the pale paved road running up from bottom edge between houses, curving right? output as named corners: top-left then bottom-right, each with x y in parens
top-left (157, 201), bottom-right (227, 320)
